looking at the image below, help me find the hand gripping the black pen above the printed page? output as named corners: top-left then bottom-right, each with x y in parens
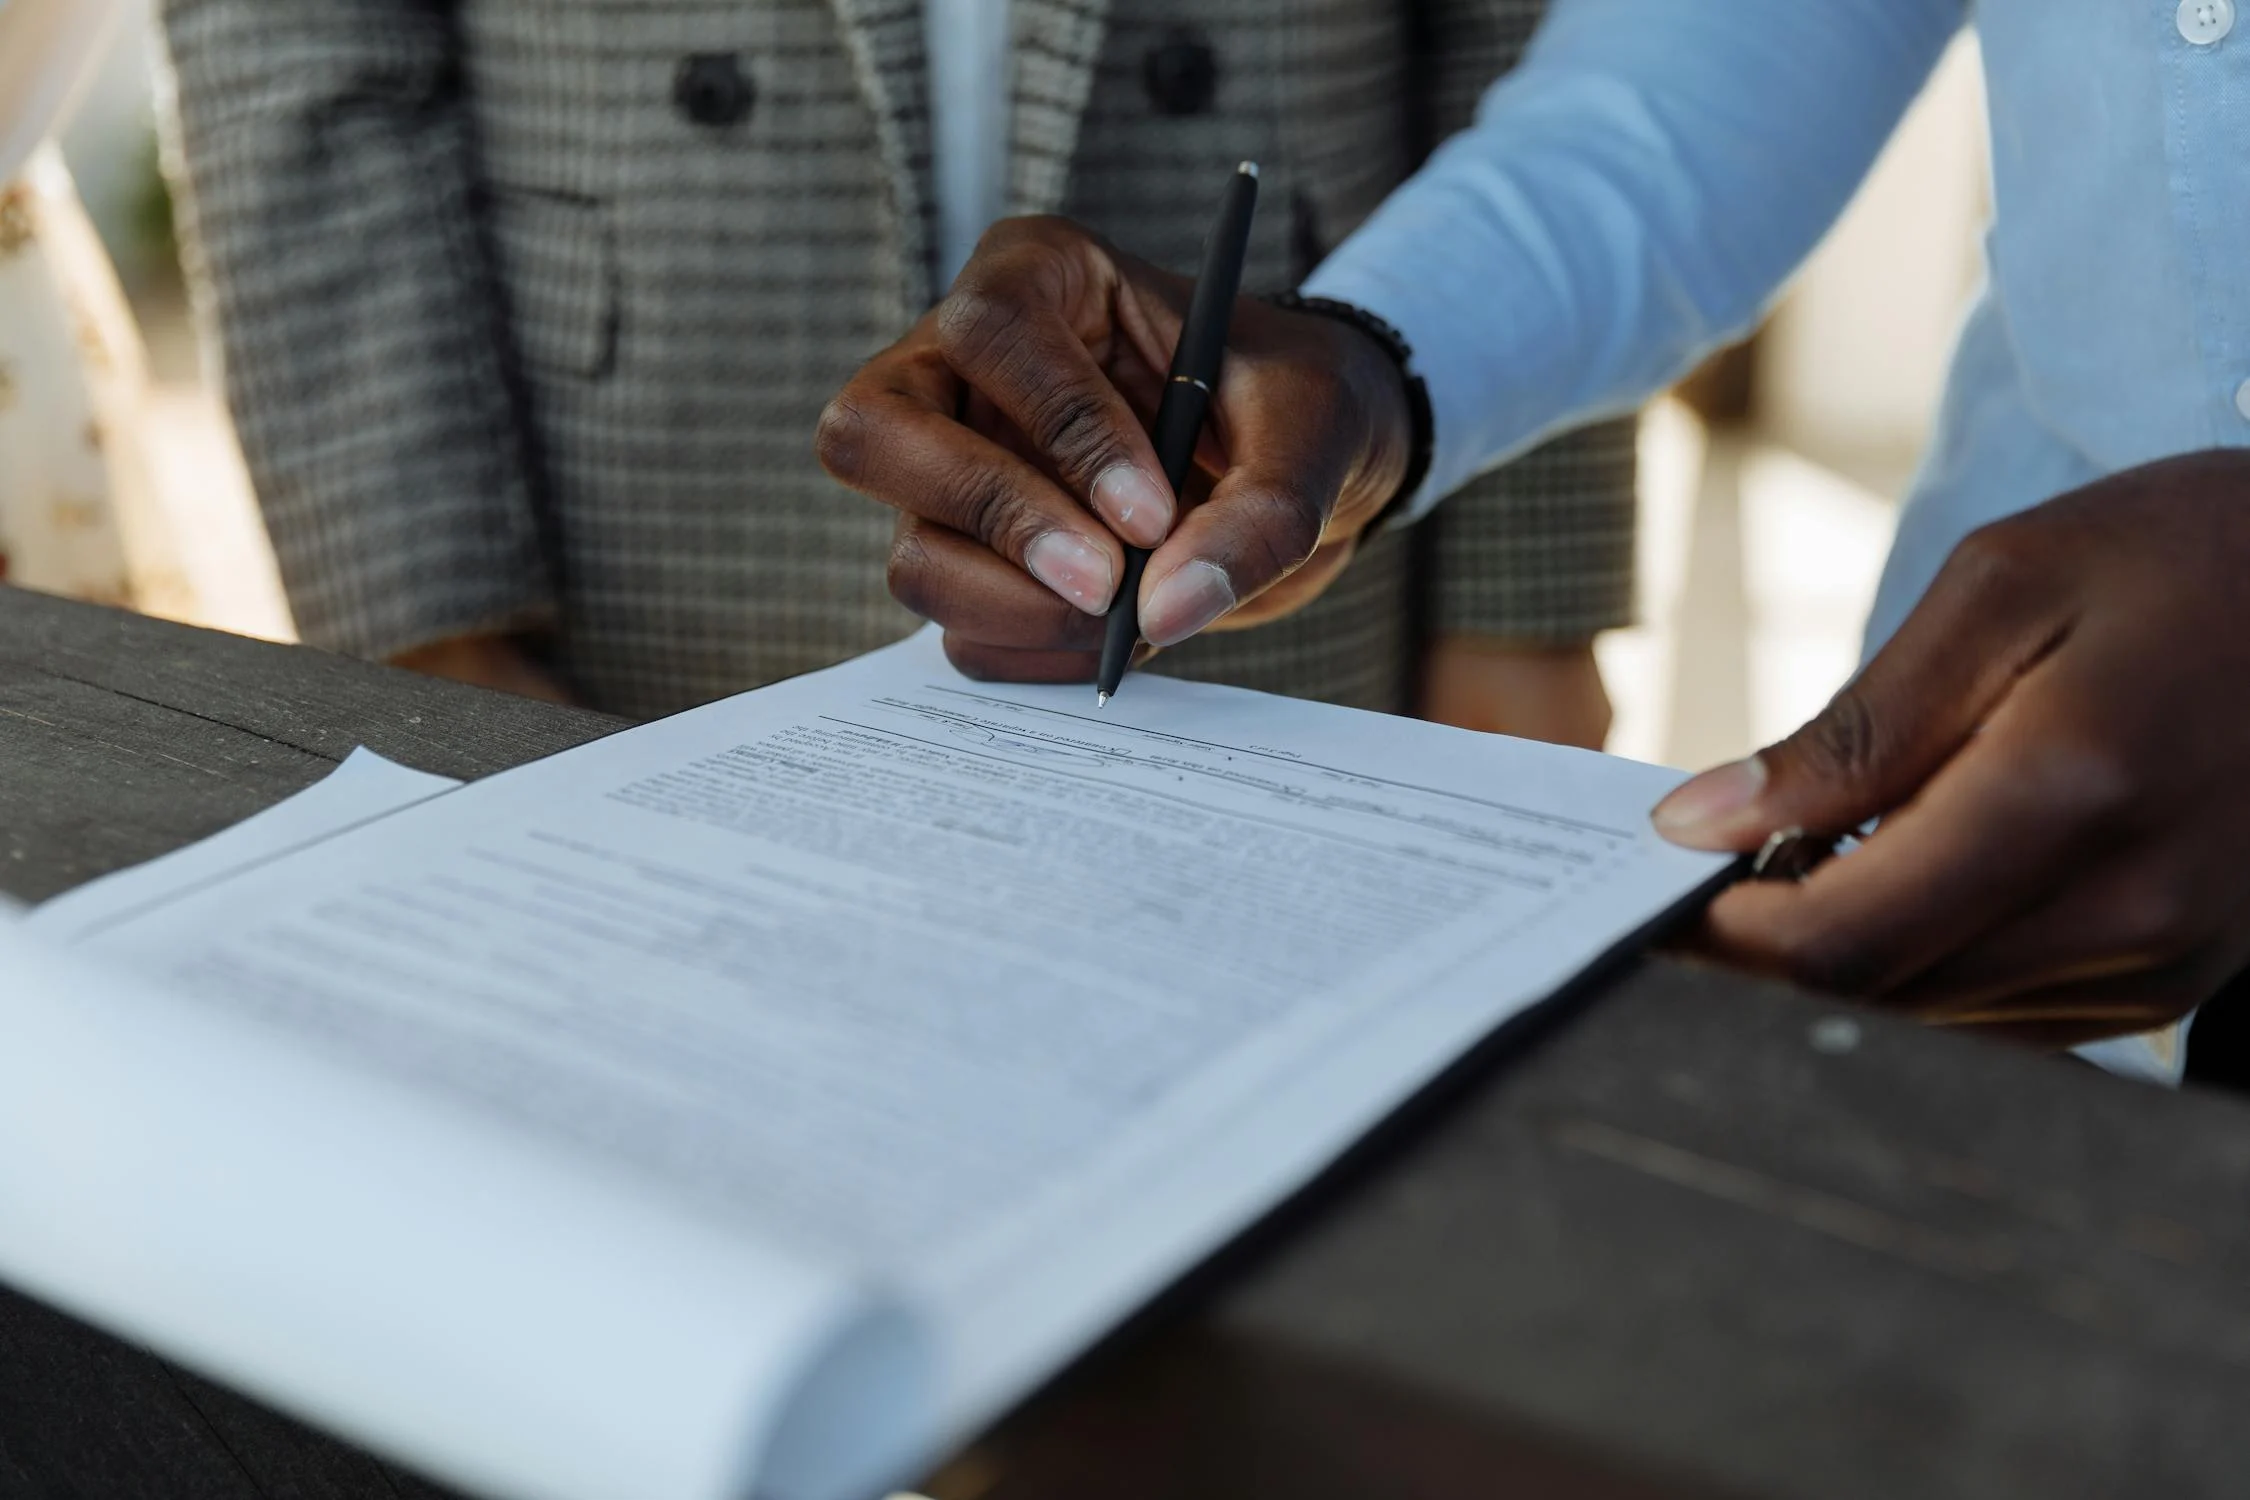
top-left (819, 187), bottom-right (1413, 681)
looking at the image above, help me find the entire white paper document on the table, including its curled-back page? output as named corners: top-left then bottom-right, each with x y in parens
top-left (0, 634), bottom-right (1726, 1500)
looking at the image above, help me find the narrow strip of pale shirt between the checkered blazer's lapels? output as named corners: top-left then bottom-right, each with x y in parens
top-left (923, 0), bottom-right (1010, 290)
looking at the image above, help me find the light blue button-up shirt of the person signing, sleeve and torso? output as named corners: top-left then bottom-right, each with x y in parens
top-left (1307, 0), bottom-right (2250, 645)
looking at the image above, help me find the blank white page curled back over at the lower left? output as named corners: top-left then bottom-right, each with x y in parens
top-left (0, 920), bottom-right (929, 1500)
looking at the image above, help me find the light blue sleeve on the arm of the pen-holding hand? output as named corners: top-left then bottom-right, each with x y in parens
top-left (1305, 0), bottom-right (1967, 515)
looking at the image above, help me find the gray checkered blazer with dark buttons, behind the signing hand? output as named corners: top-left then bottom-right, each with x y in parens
top-left (164, 0), bottom-right (1634, 715)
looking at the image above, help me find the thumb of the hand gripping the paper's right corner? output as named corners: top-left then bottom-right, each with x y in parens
top-left (1652, 524), bottom-right (2070, 852)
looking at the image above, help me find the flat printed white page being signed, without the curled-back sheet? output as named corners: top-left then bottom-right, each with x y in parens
top-left (70, 634), bottom-right (1724, 1457)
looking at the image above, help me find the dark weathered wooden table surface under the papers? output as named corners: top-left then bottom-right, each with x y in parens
top-left (13, 589), bottom-right (2250, 1500)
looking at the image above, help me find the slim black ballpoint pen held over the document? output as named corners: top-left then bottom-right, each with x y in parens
top-left (1094, 162), bottom-right (1258, 708)
